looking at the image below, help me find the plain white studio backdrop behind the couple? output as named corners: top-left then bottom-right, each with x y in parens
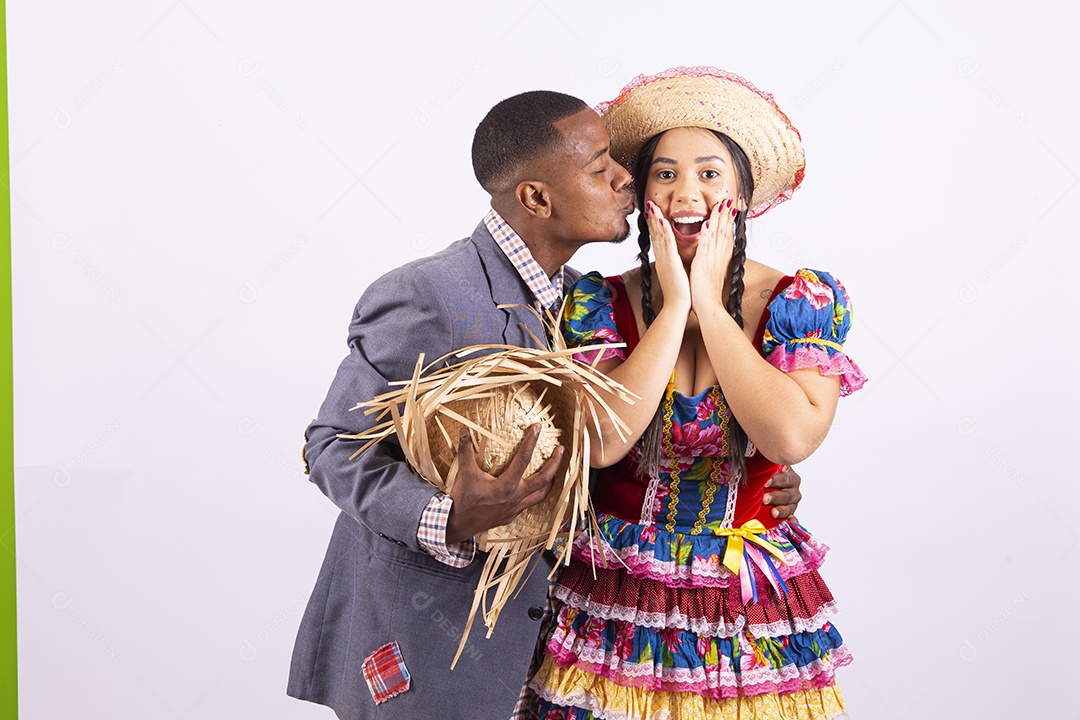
top-left (8, 0), bottom-right (1080, 720)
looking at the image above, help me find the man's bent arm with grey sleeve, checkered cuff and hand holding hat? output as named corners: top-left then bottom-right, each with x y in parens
top-left (305, 268), bottom-right (563, 566)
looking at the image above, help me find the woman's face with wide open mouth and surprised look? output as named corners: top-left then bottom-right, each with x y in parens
top-left (645, 127), bottom-right (745, 262)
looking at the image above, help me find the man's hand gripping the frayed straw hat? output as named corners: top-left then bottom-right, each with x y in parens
top-left (446, 424), bottom-right (564, 544)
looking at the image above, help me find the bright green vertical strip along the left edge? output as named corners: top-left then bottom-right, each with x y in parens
top-left (0, 0), bottom-right (18, 718)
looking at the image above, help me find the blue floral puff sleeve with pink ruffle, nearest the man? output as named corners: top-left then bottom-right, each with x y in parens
top-left (562, 272), bottom-right (626, 365)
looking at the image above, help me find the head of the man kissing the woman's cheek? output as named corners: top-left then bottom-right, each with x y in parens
top-left (472, 91), bottom-right (634, 264)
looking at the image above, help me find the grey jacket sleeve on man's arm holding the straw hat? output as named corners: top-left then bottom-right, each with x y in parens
top-left (305, 267), bottom-right (455, 552)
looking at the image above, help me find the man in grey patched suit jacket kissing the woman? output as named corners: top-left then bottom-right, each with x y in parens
top-left (288, 92), bottom-right (798, 720)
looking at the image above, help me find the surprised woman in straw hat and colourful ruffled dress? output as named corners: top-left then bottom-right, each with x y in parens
top-left (531, 68), bottom-right (865, 720)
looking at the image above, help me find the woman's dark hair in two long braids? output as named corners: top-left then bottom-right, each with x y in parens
top-left (634, 131), bottom-right (754, 479)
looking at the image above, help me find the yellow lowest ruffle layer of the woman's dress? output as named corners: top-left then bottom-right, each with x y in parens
top-left (537, 663), bottom-right (845, 720)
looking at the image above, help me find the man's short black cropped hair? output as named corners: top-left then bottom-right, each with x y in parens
top-left (472, 90), bottom-right (589, 193)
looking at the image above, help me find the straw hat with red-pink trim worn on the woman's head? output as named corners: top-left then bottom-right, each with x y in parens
top-left (596, 67), bottom-right (806, 217)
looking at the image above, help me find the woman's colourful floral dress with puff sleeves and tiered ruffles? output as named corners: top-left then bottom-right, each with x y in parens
top-left (531, 270), bottom-right (865, 720)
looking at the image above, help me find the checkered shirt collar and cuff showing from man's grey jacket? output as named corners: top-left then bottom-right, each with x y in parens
top-left (416, 209), bottom-right (563, 568)
